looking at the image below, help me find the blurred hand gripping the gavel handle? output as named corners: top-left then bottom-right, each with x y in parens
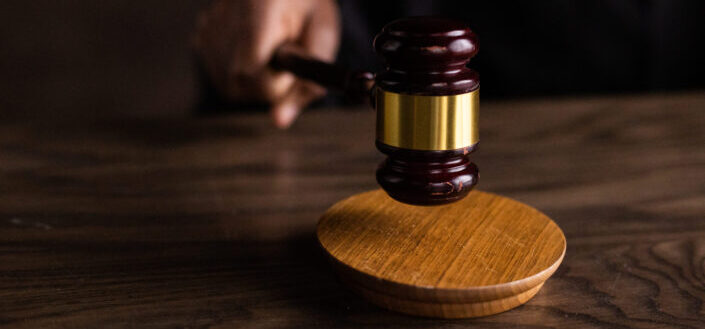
top-left (194, 0), bottom-right (340, 128)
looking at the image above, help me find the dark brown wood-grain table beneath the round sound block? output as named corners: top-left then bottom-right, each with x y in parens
top-left (0, 92), bottom-right (705, 328)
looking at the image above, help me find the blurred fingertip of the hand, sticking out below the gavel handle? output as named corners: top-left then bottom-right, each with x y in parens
top-left (270, 80), bottom-right (325, 129)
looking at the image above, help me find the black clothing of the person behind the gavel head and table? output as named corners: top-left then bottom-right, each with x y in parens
top-left (338, 0), bottom-right (705, 98)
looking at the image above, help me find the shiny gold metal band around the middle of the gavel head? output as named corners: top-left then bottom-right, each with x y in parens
top-left (375, 88), bottom-right (480, 151)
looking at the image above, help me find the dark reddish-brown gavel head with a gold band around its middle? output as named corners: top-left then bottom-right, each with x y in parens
top-left (374, 17), bottom-right (480, 205)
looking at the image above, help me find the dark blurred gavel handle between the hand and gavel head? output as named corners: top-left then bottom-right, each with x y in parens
top-left (270, 43), bottom-right (374, 102)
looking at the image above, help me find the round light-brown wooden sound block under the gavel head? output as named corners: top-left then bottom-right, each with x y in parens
top-left (317, 190), bottom-right (566, 318)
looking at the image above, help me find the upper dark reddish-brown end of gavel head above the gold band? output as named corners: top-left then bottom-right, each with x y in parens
top-left (374, 17), bottom-right (480, 96)
